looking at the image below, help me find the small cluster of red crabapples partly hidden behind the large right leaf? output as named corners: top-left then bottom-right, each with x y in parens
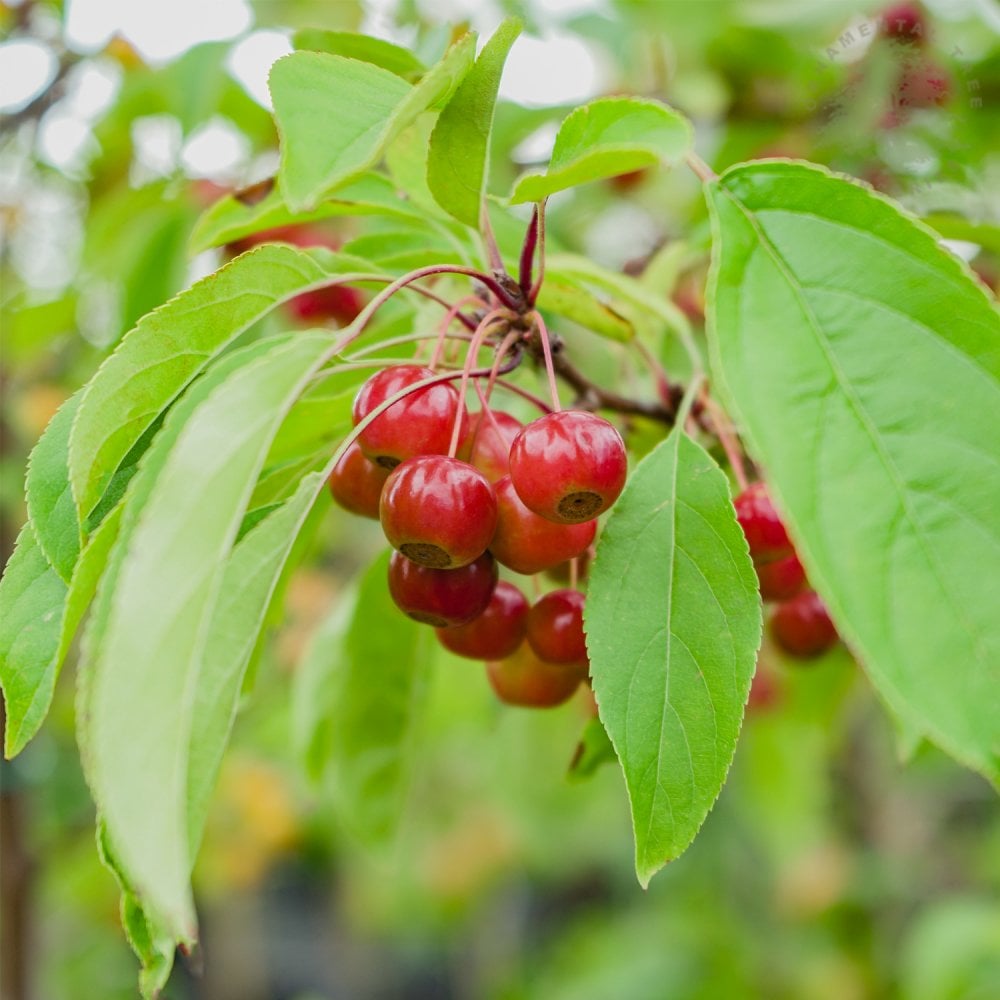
top-left (734, 482), bottom-right (837, 659)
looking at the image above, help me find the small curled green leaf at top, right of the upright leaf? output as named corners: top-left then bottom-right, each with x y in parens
top-left (511, 97), bottom-right (692, 204)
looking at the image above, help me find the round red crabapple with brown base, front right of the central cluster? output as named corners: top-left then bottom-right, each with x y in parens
top-left (510, 410), bottom-right (628, 524)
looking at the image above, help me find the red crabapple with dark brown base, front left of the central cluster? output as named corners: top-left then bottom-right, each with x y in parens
top-left (379, 455), bottom-right (497, 569)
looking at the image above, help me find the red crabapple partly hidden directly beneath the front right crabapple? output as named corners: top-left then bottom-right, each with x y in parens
top-left (490, 476), bottom-right (597, 576)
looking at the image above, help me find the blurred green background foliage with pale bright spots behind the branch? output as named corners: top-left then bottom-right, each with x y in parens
top-left (0, 0), bottom-right (1000, 1000)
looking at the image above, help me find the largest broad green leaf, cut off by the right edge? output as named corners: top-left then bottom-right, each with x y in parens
top-left (707, 163), bottom-right (1000, 781)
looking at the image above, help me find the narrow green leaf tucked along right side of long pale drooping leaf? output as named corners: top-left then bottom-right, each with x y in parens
top-left (187, 473), bottom-right (325, 858)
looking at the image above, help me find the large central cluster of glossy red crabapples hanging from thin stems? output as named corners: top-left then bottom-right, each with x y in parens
top-left (330, 364), bottom-right (627, 707)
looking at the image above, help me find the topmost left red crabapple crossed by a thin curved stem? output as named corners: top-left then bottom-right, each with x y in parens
top-left (352, 365), bottom-right (467, 469)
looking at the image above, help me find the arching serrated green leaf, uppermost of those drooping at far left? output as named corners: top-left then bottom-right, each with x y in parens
top-left (69, 245), bottom-right (370, 515)
